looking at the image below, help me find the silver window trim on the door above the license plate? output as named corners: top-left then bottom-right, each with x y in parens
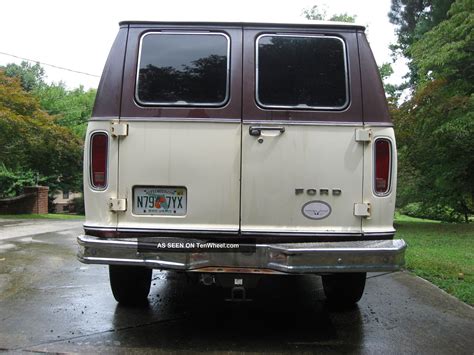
top-left (135, 31), bottom-right (231, 107)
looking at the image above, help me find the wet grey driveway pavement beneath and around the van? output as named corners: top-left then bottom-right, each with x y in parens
top-left (0, 219), bottom-right (474, 354)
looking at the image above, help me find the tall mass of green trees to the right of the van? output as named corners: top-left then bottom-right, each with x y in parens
top-left (394, 0), bottom-right (474, 222)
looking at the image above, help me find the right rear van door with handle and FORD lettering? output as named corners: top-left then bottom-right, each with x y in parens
top-left (241, 27), bottom-right (364, 236)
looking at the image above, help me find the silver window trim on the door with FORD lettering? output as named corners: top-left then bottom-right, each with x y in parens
top-left (255, 33), bottom-right (351, 111)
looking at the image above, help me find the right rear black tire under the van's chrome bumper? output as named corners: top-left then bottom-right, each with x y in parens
top-left (322, 272), bottom-right (367, 307)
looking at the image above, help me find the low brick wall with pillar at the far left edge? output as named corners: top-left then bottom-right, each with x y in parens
top-left (0, 186), bottom-right (49, 214)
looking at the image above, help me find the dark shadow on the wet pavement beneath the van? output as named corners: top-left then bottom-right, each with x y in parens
top-left (109, 273), bottom-right (363, 352)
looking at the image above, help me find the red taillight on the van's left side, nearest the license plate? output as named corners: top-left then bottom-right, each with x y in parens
top-left (90, 133), bottom-right (109, 189)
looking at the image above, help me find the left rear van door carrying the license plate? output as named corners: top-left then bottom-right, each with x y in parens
top-left (117, 24), bottom-right (242, 234)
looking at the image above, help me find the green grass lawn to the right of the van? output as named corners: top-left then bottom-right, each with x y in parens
top-left (395, 215), bottom-right (474, 305)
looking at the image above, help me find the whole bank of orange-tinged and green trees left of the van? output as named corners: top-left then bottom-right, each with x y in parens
top-left (0, 62), bottom-right (96, 210)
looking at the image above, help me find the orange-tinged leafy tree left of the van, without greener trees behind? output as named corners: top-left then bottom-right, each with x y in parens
top-left (0, 70), bottom-right (82, 194)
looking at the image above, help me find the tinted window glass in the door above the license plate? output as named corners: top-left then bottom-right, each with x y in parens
top-left (137, 33), bottom-right (229, 106)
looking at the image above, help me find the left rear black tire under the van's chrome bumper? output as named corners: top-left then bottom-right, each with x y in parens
top-left (109, 265), bottom-right (153, 305)
